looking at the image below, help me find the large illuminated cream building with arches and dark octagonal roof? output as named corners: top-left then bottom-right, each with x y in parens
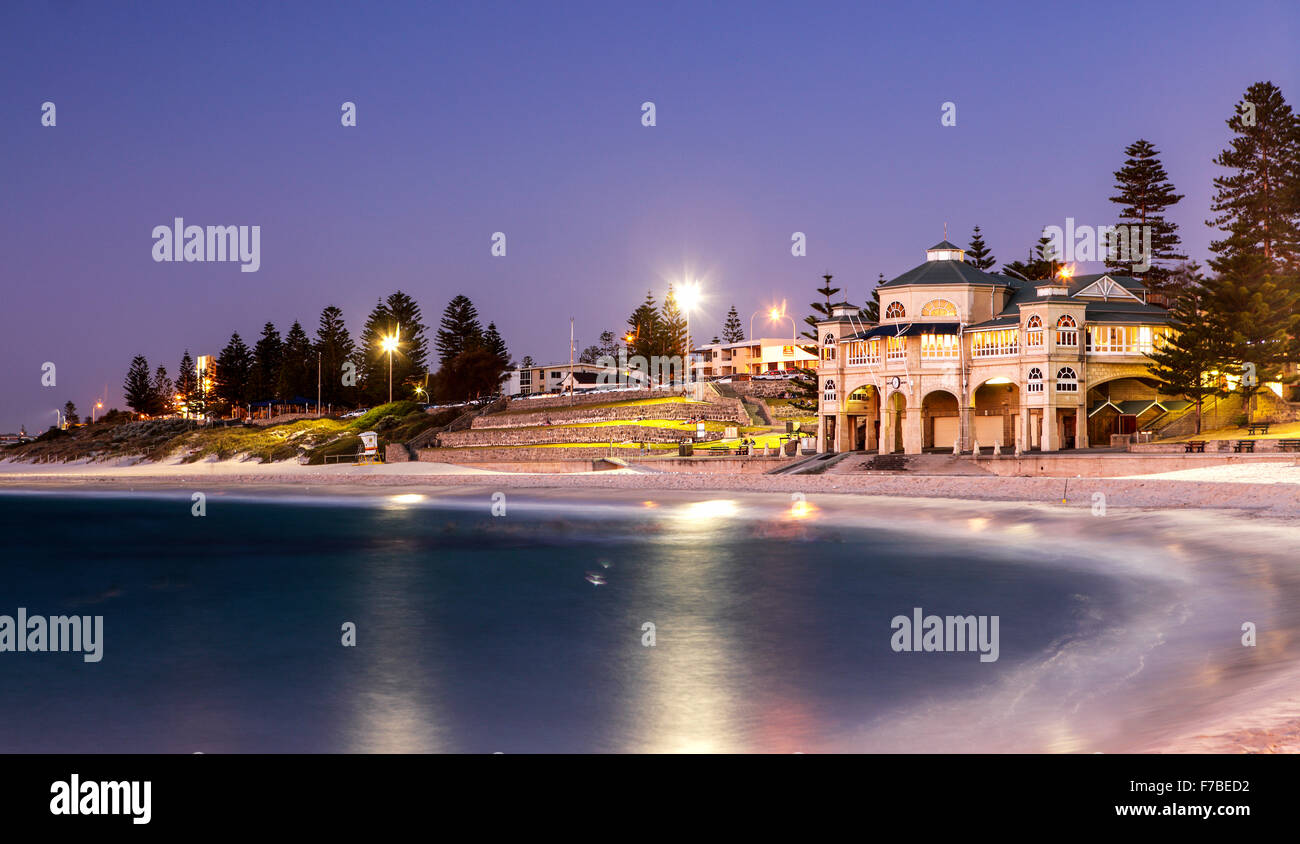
top-left (818, 241), bottom-right (1188, 454)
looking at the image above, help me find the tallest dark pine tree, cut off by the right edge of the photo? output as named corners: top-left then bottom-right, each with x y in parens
top-left (1209, 82), bottom-right (1300, 404)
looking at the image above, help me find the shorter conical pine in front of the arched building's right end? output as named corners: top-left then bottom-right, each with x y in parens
top-left (1148, 264), bottom-right (1231, 433)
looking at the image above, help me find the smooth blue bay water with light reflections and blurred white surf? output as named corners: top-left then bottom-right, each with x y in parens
top-left (0, 492), bottom-right (1300, 753)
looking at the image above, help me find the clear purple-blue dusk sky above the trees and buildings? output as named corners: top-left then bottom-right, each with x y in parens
top-left (0, 0), bottom-right (1300, 433)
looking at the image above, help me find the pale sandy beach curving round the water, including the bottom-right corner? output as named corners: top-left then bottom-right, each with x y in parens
top-left (0, 460), bottom-right (1300, 753)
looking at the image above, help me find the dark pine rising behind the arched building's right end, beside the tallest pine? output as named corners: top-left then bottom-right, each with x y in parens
top-left (1099, 139), bottom-right (1187, 294)
